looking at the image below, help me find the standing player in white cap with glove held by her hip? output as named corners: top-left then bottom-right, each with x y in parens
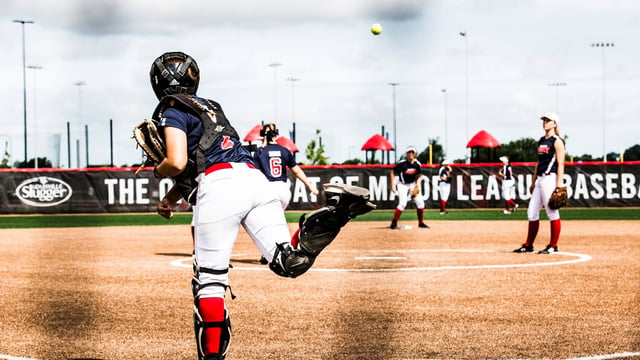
top-left (514, 113), bottom-right (567, 254)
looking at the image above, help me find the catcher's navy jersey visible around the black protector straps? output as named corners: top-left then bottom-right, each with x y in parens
top-left (158, 97), bottom-right (255, 168)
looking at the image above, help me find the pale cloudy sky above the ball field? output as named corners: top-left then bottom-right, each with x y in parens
top-left (0, 0), bottom-right (640, 167)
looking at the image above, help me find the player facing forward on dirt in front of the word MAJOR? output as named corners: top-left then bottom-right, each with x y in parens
top-left (389, 146), bottom-right (429, 229)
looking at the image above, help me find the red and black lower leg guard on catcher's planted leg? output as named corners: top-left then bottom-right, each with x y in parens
top-left (193, 298), bottom-right (231, 360)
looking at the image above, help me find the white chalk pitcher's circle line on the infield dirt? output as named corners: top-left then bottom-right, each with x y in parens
top-left (171, 249), bottom-right (591, 273)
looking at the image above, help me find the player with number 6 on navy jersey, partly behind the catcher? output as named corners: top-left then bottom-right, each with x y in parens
top-left (253, 124), bottom-right (318, 209)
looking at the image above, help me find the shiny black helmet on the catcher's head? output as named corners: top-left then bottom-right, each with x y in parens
top-left (149, 52), bottom-right (200, 100)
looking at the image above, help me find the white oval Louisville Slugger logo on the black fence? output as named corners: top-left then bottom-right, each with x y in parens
top-left (16, 176), bottom-right (73, 207)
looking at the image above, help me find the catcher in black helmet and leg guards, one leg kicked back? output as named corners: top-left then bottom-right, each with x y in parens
top-left (134, 52), bottom-right (375, 360)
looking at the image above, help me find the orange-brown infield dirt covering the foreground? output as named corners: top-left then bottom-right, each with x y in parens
top-left (0, 221), bottom-right (640, 360)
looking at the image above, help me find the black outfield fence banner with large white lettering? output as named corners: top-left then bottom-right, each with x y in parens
top-left (0, 161), bottom-right (640, 214)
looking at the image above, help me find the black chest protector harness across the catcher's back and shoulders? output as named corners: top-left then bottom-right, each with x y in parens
top-left (153, 94), bottom-right (240, 175)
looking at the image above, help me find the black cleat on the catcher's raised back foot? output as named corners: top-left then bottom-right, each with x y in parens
top-left (323, 184), bottom-right (376, 219)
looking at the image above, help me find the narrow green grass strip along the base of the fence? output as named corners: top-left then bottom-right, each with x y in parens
top-left (0, 208), bottom-right (640, 229)
